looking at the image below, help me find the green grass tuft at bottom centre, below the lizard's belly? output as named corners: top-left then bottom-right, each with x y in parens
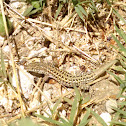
top-left (35, 82), bottom-right (113, 126)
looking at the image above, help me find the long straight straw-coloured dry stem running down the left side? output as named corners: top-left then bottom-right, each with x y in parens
top-left (0, 0), bottom-right (25, 117)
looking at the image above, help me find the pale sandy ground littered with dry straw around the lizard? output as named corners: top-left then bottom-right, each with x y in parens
top-left (0, 1), bottom-right (125, 126)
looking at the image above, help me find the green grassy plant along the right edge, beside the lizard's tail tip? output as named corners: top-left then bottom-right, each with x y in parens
top-left (105, 26), bottom-right (126, 126)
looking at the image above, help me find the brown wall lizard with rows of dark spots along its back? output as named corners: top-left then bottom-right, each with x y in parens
top-left (24, 59), bottom-right (118, 89)
